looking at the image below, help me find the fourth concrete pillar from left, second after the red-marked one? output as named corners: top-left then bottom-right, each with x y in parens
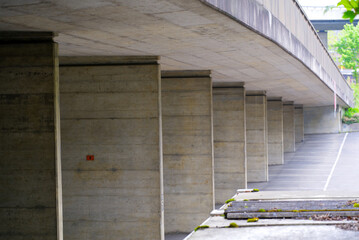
top-left (213, 86), bottom-right (247, 204)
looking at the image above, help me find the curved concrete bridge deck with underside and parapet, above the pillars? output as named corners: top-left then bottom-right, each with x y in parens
top-left (0, 0), bottom-right (352, 107)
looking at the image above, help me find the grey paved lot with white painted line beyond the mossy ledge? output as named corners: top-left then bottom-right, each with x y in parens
top-left (248, 133), bottom-right (352, 191)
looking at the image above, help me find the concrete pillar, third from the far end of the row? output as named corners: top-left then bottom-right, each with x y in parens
top-left (267, 97), bottom-right (284, 165)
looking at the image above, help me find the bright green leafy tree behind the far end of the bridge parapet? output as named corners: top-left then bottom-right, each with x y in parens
top-left (334, 24), bottom-right (359, 83)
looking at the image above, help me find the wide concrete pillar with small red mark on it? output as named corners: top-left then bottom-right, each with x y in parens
top-left (60, 56), bottom-right (164, 240)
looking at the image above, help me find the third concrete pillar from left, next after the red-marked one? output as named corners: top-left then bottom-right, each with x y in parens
top-left (162, 71), bottom-right (214, 233)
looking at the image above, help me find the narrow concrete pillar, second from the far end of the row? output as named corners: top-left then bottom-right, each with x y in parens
top-left (283, 102), bottom-right (295, 152)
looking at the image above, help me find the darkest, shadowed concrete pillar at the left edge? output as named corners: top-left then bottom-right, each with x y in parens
top-left (0, 32), bottom-right (63, 240)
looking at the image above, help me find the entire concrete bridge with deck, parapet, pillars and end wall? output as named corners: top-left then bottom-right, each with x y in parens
top-left (0, 0), bottom-right (353, 239)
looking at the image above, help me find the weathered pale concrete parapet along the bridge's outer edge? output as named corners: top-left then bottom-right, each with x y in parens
top-left (202, 0), bottom-right (354, 106)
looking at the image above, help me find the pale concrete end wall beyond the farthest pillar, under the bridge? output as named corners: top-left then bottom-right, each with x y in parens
top-left (304, 106), bottom-right (342, 134)
